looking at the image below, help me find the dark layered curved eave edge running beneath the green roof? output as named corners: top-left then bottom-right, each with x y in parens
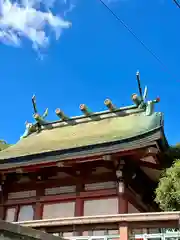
top-left (0, 127), bottom-right (164, 170)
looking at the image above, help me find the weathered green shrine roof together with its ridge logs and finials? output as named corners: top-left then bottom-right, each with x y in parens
top-left (0, 71), bottom-right (163, 159)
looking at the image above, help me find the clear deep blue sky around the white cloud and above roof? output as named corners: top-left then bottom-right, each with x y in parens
top-left (0, 0), bottom-right (180, 144)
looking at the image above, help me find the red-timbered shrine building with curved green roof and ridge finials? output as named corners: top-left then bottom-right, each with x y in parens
top-left (0, 72), bottom-right (169, 237)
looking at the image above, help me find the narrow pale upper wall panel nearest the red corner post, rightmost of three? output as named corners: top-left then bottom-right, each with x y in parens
top-left (84, 181), bottom-right (116, 191)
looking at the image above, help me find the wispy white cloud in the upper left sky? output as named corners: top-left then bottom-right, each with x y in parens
top-left (0, 0), bottom-right (71, 49)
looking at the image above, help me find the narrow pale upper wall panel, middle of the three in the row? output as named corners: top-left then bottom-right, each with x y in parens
top-left (45, 186), bottom-right (76, 195)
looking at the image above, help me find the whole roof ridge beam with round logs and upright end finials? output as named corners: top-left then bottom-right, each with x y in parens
top-left (21, 72), bottom-right (160, 138)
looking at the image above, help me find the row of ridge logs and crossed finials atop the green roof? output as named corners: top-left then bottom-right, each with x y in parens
top-left (21, 71), bottom-right (160, 138)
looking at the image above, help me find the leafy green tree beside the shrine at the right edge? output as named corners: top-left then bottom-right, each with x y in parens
top-left (155, 144), bottom-right (180, 211)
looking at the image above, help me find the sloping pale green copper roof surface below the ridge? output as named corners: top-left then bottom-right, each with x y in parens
top-left (0, 111), bottom-right (162, 159)
